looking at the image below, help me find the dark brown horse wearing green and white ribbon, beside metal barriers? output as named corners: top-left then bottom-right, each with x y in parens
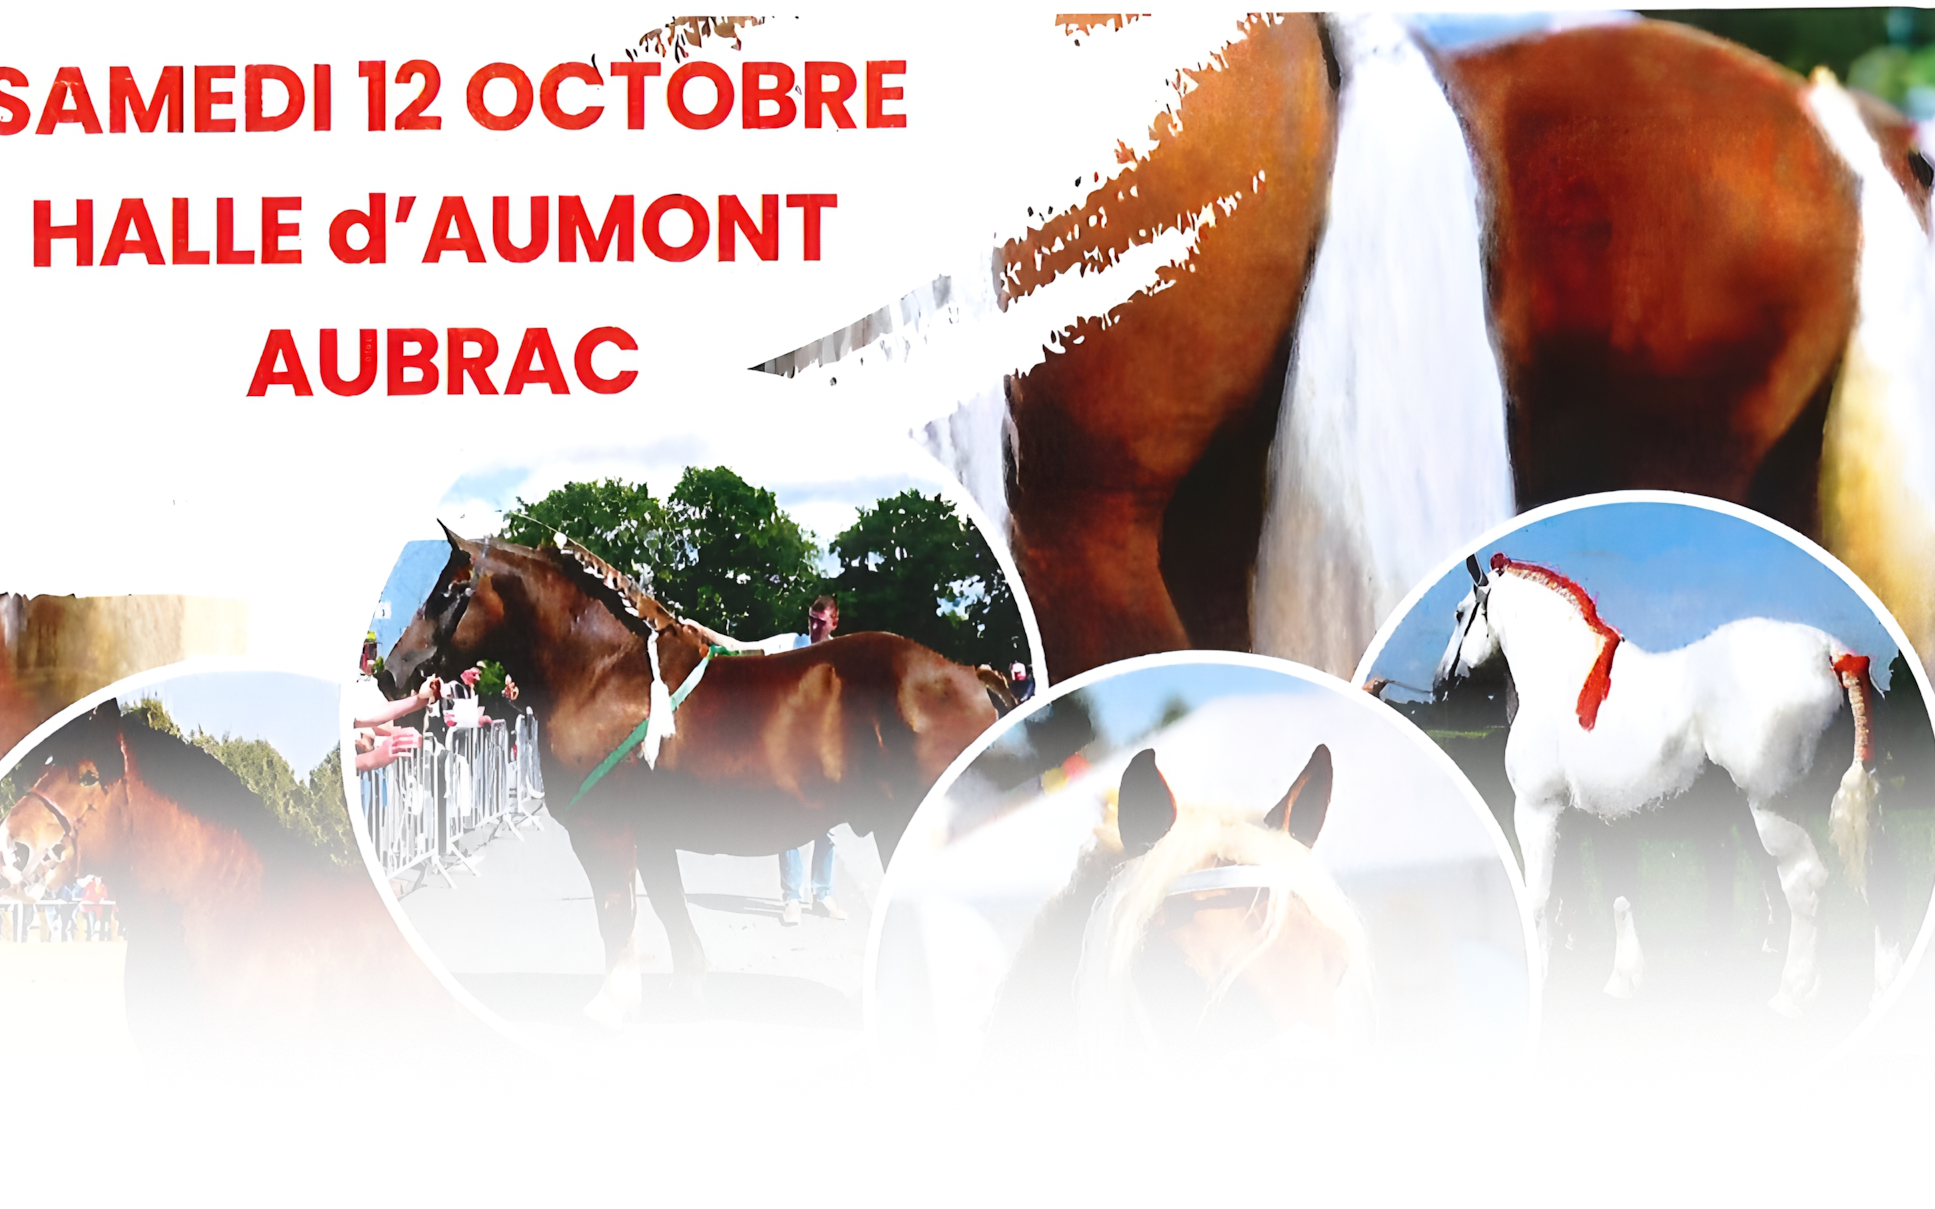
top-left (379, 528), bottom-right (1012, 1025)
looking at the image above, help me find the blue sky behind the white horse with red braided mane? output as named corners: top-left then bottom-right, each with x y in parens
top-left (1372, 501), bottom-right (1898, 696)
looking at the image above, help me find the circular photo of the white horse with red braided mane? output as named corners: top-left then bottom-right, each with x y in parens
top-left (1356, 491), bottom-right (1935, 1064)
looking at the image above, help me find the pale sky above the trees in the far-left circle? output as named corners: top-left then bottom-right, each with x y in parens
top-left (120, 671), bottom-right (342, 778)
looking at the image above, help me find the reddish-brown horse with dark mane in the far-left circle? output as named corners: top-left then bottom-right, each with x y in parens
top-left (0, 700), bottom-right (464, 1054)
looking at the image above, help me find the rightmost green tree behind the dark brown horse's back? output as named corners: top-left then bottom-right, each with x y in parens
top-left (826, 487), bottom-right (1027, 671)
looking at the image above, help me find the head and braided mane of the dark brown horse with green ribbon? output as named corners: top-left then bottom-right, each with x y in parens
top-left (377, 526), bottom-right (702, 698)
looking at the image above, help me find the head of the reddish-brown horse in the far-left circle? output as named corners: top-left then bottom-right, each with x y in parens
top-left (0, 700), bottom-right (128, 885)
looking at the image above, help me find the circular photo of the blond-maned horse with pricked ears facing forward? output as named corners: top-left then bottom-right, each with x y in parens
top-left (867, 652), bottom-right (1538, 1064)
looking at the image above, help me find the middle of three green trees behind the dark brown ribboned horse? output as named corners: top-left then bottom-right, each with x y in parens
top-left (652, 466), bottom-right (820, 638)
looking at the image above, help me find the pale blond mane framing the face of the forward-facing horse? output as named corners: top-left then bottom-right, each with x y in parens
top-left (1076, 805), bottom-right (1370, 1052)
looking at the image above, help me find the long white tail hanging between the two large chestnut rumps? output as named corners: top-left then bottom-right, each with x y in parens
top-left (1250, 14), bottom-right (1515, 675)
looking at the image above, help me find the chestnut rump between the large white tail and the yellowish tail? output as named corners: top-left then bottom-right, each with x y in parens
top-left (1445, 23), bottom-right (1860, 528)
